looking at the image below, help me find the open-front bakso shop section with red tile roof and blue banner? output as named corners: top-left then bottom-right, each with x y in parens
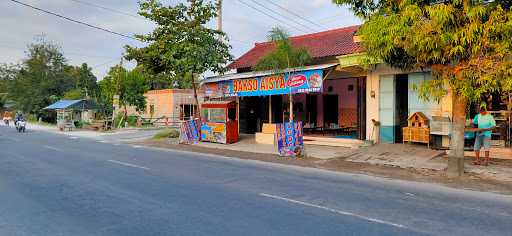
top-left (202, 26), bottom-right (366, 145)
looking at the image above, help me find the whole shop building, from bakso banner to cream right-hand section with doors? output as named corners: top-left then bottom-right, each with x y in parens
top-left (202, 26), bottom-right (510, 147)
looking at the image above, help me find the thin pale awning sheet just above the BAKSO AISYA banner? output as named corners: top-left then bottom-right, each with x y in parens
top-left (201, 63), bottom-right (339, 84)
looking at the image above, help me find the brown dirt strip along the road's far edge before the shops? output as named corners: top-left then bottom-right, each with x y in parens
top-left (137, 140), bottom-right (512, 195)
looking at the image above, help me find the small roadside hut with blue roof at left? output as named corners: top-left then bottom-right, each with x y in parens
top-left (44, 99), bottom-right (98, 130)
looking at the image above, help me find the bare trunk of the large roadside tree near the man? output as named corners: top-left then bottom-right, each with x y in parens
top-left (447, 94), bottom-right (467, 177)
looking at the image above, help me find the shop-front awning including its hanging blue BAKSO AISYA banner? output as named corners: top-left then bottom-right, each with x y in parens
top-left (202, 63), bottom-right (339, 98)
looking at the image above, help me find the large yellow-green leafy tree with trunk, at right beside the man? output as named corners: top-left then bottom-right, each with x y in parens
top-left (334, 0), bottom-right (512, 175)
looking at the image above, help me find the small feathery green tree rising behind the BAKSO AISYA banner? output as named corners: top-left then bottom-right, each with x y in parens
top-left (254, 27), bottom-right (311, 122)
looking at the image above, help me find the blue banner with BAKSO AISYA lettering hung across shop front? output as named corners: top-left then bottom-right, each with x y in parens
top-left (205, 70), bottom-right (324, 97)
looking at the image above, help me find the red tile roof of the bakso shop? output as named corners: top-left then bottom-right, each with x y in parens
top-left (228, 25), bottom-right (363, 69)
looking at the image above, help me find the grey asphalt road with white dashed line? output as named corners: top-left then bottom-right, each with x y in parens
top-left (0, 126), bottom-right (512, 236)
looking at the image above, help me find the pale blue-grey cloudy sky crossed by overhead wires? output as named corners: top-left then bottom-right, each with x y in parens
top-left (0, 0), bottom-right (361, 79)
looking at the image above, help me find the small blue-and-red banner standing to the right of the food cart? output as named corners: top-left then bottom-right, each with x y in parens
top-left (276, 122), bottom-right (304, 157)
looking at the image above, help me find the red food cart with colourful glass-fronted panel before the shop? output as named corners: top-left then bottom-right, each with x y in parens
top-left (201, 101), bottom-right (238, 144)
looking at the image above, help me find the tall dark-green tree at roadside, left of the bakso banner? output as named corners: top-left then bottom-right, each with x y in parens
top-left (126, 0), bottom-right (232, 116)
